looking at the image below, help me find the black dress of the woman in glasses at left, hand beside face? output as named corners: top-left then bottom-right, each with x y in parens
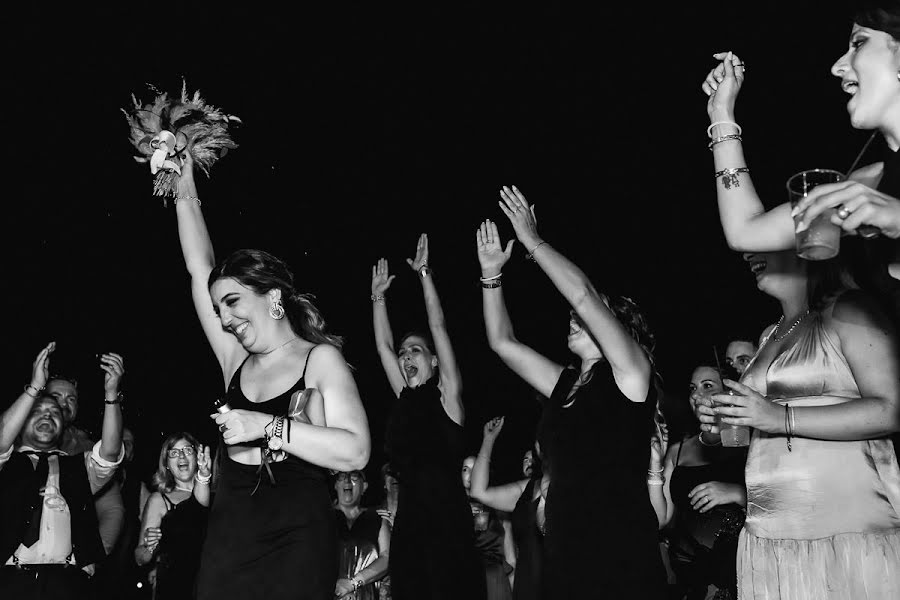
top-left (154, 494), bottom-right (207, 600)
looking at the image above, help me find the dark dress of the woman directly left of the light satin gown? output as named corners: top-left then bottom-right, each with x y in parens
top-left (668, 441), bottom-right (747, 598)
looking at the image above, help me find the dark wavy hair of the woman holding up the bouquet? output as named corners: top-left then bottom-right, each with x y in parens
top-left (207, 249), bottom-right (344, 348)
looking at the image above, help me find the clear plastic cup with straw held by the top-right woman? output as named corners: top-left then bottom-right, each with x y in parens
top-left (787, 169), bottom-right (844, 260)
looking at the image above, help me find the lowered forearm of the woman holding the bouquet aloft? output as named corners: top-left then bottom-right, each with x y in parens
top-left (282, 421), bottom-right (370, 472)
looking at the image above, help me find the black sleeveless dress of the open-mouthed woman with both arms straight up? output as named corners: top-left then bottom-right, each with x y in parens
top-left (385, 378), bottom-right (485, 600)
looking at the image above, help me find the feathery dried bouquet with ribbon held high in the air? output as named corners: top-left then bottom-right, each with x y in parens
top-left (122, 81), bottom-right (241, 204)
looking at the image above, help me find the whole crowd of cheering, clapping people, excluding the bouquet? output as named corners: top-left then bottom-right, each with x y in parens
top-left (0, 2), bottom-right (900, 600)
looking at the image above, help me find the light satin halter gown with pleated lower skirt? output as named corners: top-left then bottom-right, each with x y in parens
top-left (737, 308), bottom-right (900, 600)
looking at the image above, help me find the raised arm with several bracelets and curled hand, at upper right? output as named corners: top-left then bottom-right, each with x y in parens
top-left (702, 52), bottom-right (794, 252)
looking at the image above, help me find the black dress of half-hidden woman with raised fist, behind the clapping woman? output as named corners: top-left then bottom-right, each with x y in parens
top-left (511, 479), bottom-right (544, 600)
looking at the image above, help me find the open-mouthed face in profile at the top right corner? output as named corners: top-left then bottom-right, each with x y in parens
top-left (831, 24), bottom-right (900, 129)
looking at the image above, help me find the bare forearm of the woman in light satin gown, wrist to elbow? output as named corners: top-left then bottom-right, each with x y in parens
top-left (785, 398), bottom-right (900, 441)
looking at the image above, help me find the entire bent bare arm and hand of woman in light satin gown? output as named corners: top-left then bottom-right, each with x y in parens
top-left (713, 291), bottom-right (900, 441)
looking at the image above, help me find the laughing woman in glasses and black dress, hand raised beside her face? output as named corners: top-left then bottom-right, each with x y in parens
top-left (134, 432), bottom-right (210, 600)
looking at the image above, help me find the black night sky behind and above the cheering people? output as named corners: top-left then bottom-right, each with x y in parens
top-left (0, 2), bottom-right (878, 502)
